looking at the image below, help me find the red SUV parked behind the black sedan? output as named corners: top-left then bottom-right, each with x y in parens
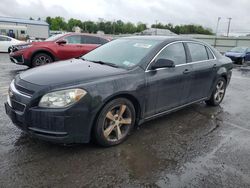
top-left (10, 33), bottom-right (110, 67)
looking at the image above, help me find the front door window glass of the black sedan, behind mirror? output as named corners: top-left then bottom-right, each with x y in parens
top-left (156, 42), bottom-right (187, 65)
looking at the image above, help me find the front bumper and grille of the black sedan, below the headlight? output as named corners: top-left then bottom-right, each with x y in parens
top-left (5, 78), bottom-right (94, 143)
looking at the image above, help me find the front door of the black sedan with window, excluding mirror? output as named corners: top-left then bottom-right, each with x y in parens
top-left (145, 42), bottom-right (192, 116)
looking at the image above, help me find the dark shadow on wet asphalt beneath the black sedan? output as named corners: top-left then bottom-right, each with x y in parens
top-left (12, 103), bottom-right (223, 151)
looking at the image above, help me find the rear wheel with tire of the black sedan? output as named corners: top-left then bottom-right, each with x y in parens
top-left (205, 77), bottom-right (227, 106)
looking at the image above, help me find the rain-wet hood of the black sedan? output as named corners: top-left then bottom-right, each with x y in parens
top-left (20, 59), bottom-right (127, 86)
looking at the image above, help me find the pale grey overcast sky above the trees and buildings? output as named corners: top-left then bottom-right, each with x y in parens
top-left (0, 0), bottom-right (250, 33)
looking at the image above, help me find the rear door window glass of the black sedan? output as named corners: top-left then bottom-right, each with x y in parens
top-left (187, 43), bottom-right (208, 62)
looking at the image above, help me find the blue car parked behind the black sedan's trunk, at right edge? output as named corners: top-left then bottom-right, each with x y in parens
top-left (225, 47), bottom-right (250, 65)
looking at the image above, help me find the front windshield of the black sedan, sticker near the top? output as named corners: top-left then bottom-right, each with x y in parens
top-left (82, 38), bottom-right (160, 68)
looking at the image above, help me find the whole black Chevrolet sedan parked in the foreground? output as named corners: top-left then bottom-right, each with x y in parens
top-left (5, 36), bottom-right (232, 146)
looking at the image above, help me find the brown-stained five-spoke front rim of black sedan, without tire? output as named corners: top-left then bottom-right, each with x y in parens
top-left (103, 104), bottom-right (132, 141)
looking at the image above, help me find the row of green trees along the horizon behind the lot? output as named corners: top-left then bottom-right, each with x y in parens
top-left (46, 16), bottom-right (213, 35)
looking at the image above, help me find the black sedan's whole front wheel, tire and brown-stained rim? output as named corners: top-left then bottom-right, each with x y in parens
top-left (93, 98), bottom-right (136, 147)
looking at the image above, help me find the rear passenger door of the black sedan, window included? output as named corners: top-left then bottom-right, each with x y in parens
top-left (185, 42), bottom-right (217, 102)
